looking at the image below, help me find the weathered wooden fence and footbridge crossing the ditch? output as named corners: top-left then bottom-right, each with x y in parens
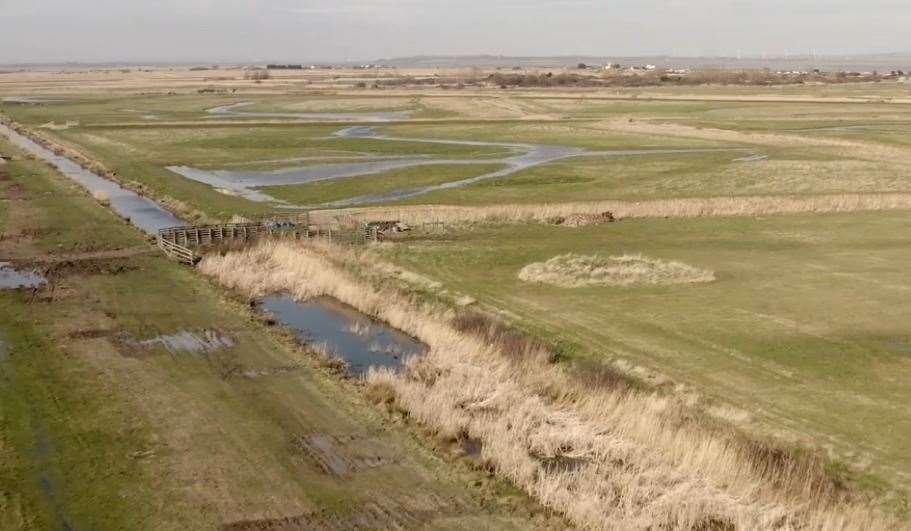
top-left (157, 215), bottom-right (377, 265)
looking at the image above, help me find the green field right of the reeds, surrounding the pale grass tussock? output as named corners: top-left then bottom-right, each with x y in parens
top-left (384, 212), bottom-right (911, 492)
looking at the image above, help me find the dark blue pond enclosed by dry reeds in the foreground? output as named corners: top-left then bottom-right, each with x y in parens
top-left (260, 295), bottom-right (425, 376)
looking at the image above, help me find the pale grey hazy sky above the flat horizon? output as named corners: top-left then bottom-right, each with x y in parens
top-left (0, 0), bottom-right (911, 63)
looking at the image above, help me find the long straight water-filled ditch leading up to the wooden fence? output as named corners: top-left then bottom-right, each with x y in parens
top-left (0, 124), bottom-right (186, 234)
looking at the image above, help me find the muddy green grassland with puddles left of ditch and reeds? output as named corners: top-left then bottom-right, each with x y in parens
top-left (0, 132), bottom-right (546, 529)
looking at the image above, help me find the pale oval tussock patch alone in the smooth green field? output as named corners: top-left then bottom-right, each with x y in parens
top-left (519, 253), bottom-right (715, 288)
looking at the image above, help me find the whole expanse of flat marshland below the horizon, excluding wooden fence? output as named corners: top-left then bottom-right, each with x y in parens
top-left (0, 53), bottom-right (911, 530)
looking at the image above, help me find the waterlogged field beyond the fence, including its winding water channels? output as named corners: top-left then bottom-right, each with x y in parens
top-left (16, 88), bottom-right (911, 219)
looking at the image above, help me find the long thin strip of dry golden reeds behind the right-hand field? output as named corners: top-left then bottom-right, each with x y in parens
top-left (313, 193), bottom-right (911, 225)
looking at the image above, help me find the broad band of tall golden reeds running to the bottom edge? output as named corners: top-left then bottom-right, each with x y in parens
top-left (200, 242), bottom-right (898, 530)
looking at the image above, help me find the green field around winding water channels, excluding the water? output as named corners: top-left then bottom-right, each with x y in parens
top-left (2, 89), bottom-right (911, 218)
